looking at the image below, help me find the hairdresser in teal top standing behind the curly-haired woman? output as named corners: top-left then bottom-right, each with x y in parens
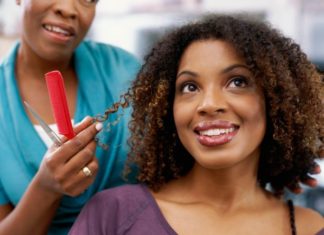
top-left (0, 0), bottom-right (139, 235)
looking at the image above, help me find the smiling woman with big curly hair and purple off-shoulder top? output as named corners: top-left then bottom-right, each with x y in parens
top-left (70, 16), bottom-right (324, 235)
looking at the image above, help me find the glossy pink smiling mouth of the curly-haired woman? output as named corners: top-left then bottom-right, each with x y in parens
top-left (194, 120), bottom-right (239, 147)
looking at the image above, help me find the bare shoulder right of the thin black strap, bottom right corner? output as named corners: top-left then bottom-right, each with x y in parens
top-left (295, 206), bottom-right (324, 234)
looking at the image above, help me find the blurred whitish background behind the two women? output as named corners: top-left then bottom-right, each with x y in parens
top-left (0, 0), bottom-right (324, 215)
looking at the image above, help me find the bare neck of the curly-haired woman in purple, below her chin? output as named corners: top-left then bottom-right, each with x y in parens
top-left (184, 165), bottom-right (260, 207)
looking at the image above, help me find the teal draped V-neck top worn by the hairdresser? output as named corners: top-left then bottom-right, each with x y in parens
top-left (0, 41), bottom-right (140, 234)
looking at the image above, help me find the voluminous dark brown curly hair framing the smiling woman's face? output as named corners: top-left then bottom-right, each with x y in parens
top-left (100, 15), bottom-right (324, 194)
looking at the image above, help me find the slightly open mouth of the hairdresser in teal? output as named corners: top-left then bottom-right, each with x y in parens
top-left (42, 23), bottom-right (75, 43)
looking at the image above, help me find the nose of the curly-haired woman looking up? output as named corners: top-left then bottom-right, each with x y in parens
top-left (197, 87), bottom-right (228, 115)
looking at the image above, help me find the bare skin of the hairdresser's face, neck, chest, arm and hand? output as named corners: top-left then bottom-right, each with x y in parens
top-left (0, 0), bottom-right (100, 235)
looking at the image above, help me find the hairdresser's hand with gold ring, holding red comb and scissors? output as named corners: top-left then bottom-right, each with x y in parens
top-left (35, 117), bottom-right (101, 198)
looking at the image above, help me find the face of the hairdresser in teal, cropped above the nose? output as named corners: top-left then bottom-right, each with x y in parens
top-left (17, 0), bottom-right (96, 60)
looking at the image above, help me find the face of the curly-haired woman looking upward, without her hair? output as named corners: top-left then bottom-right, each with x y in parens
top-left (173, 40), bottom-right (266, 169)
